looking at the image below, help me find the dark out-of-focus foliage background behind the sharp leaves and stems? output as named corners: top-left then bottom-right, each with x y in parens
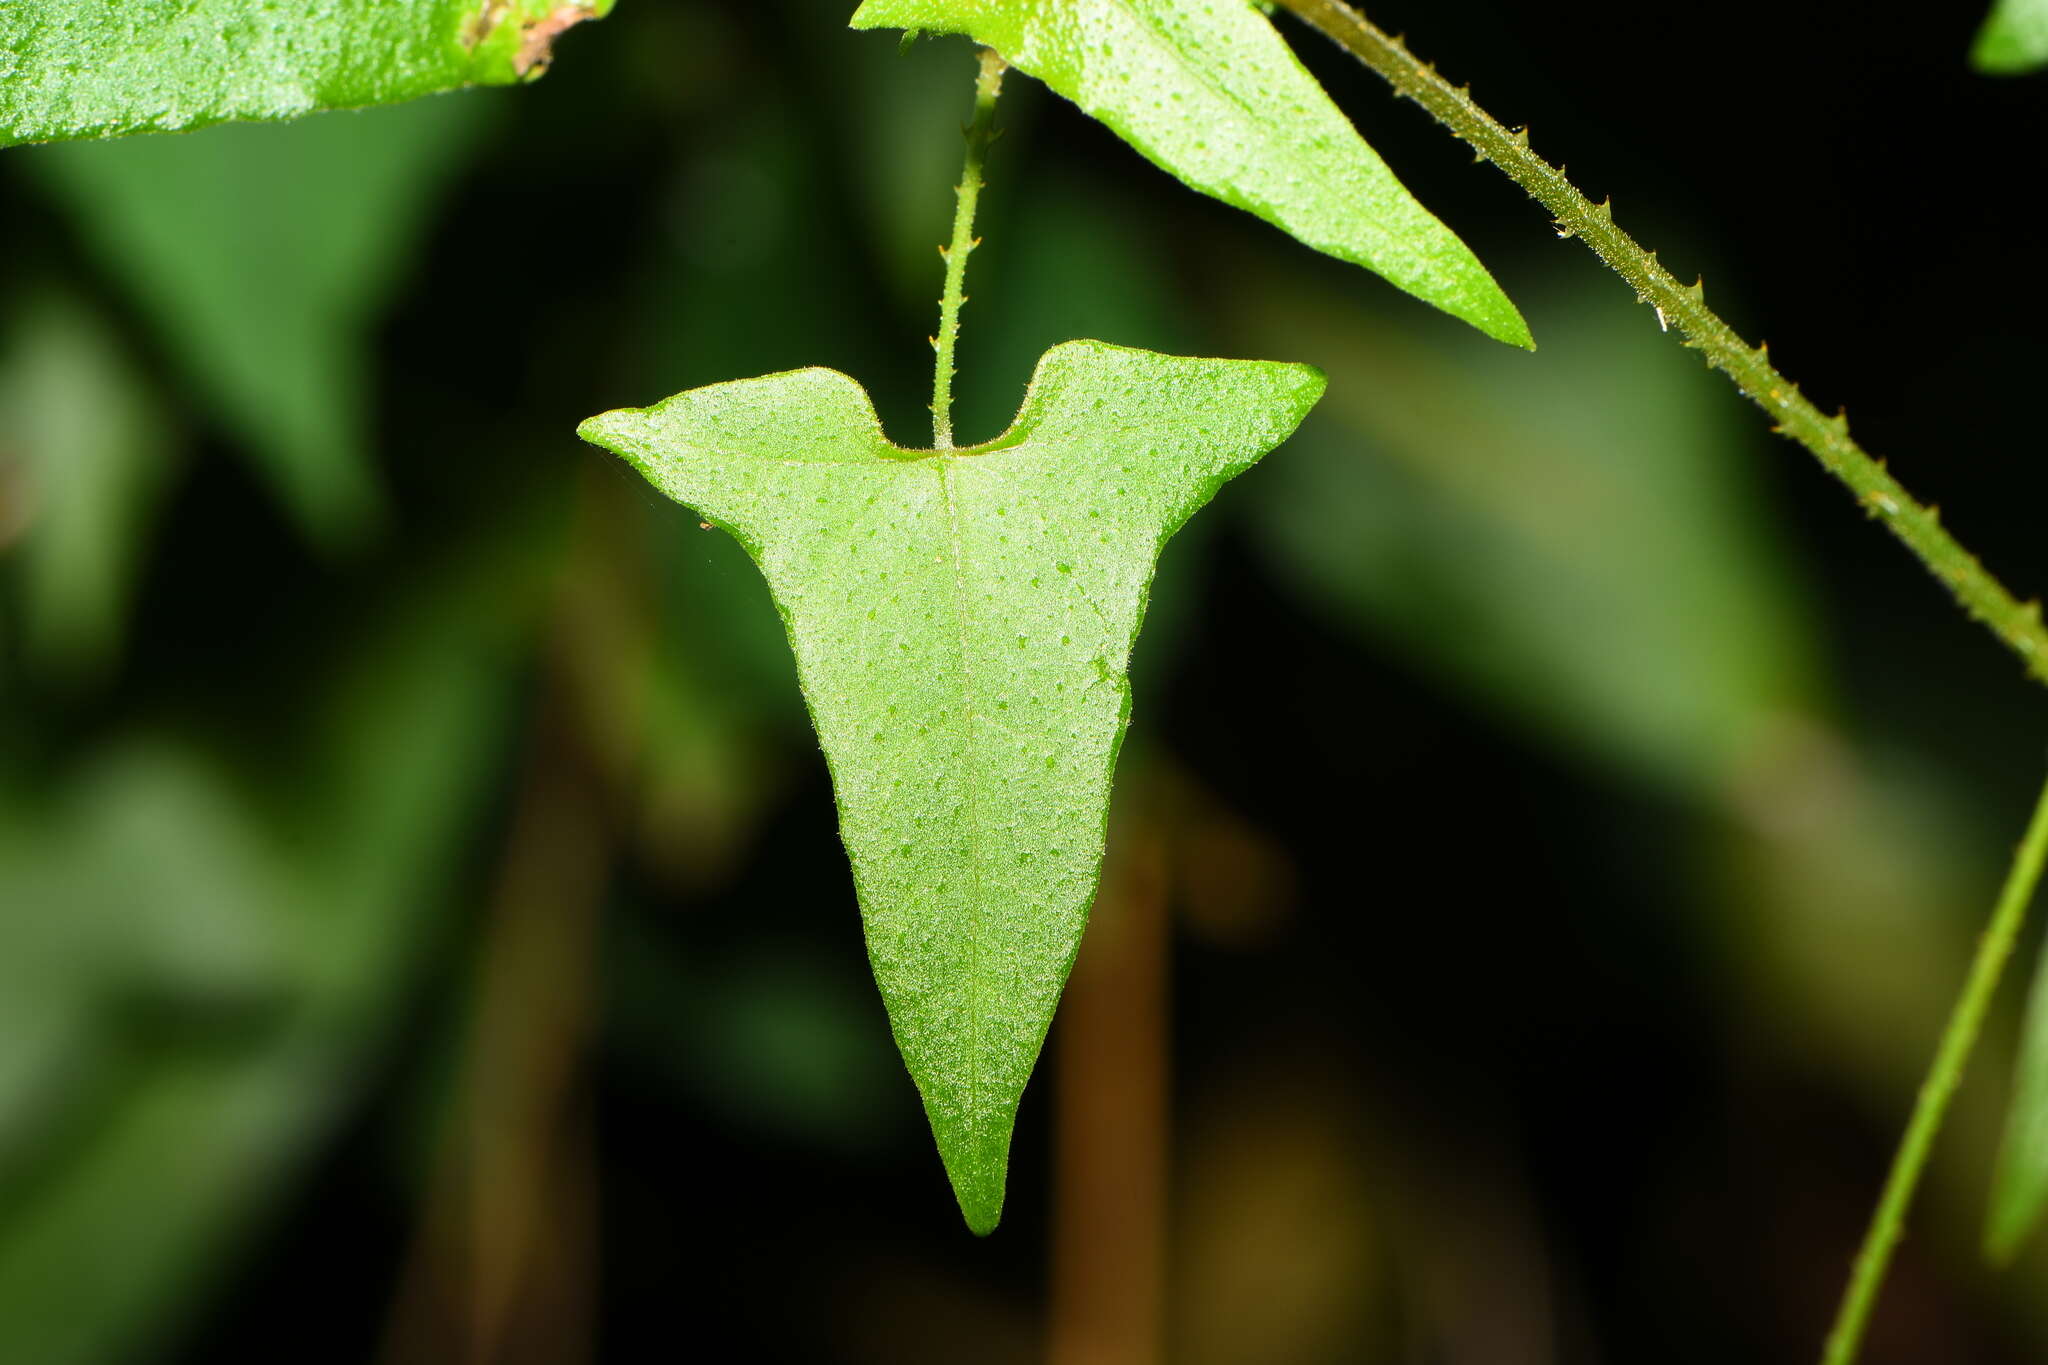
top-left (0, 0), bottom-right (2048, 1365)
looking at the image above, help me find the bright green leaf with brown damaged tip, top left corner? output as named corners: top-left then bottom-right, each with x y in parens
top-left (0, 0), bottom-right (612, 147)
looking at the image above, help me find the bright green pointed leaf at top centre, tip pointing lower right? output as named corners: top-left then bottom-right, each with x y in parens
top-left (854, 0), bottom-right (1532, 346)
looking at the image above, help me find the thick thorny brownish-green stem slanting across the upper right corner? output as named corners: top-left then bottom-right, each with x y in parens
top-left (1280, 0), bottom-right (2048, 684)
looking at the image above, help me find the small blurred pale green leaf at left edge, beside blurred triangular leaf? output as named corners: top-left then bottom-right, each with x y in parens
top-left (0, 295), bottom-right (178, 681)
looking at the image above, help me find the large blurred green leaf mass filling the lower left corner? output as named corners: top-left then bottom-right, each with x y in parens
top-left (0, 568), bottom-right (520, 1365)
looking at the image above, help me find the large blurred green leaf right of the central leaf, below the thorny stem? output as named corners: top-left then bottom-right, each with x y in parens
top-left (1237, 270), bottom-right (1817, 792)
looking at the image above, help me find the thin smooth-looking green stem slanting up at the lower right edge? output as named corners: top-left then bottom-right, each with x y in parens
top-left (1821, 777), bottom-right (2048, 1365)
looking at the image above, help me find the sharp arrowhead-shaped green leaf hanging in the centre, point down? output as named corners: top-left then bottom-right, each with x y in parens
top-left (580, 342), bottom-right (1323, 1232)
